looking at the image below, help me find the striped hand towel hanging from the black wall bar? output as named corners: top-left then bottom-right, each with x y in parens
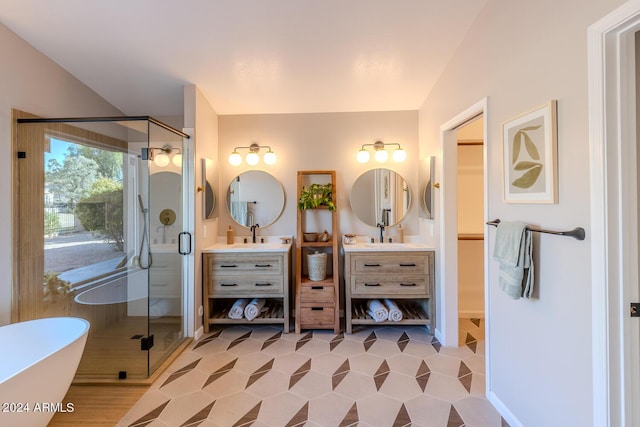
top-left (493, 221), bottom-right (534, 299)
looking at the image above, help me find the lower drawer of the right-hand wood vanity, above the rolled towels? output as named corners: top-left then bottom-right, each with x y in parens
top-left (351, 275), bottom-right (429, 296)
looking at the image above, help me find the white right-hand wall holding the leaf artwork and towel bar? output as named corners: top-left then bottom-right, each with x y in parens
top-left (419, 0), bottom-right (622, 427)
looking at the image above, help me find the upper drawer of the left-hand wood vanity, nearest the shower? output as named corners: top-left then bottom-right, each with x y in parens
top-left (207, 254), bottom-right (283, 275)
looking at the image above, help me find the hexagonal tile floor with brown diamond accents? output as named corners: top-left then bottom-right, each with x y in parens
top-left (118, 319), bottom-right (507, 427)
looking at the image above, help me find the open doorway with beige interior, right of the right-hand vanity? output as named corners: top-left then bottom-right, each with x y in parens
top-left (457, 116), bottom-right (485, 349)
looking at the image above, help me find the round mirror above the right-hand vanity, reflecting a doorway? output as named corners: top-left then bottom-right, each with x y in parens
top-left (349, 169), bottom-right (411, 227)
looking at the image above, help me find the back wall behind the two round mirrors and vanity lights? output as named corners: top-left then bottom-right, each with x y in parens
top-left (218, 111), bottom-right (418, 241)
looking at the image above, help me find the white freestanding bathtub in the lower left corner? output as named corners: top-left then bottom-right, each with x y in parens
top-left (0, 317), bottom-right (89, 427)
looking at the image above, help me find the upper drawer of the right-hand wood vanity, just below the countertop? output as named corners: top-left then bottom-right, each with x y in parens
top-left (351, 253), bottom-right (428, 274)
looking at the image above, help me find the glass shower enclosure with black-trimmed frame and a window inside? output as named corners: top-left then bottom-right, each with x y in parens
top-left (16, 116), bottom-right (191, 380)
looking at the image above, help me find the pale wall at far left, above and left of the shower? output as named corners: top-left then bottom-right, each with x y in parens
top-left (0, 24), bottom-right (122, 325)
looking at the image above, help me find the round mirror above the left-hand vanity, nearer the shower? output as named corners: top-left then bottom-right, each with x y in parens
top-left (227, 170), bottom-right (284, 228)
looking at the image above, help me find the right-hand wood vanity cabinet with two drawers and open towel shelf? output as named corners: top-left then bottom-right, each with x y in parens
top-left (344, 251), bottom-right (435, 334)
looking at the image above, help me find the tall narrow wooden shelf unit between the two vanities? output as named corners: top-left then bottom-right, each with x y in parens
top-left (295, 170), bottom-right (340, 334)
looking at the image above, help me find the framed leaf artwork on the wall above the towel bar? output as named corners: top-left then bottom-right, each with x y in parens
top-left (502, 100), bottom-right (558, 203)
